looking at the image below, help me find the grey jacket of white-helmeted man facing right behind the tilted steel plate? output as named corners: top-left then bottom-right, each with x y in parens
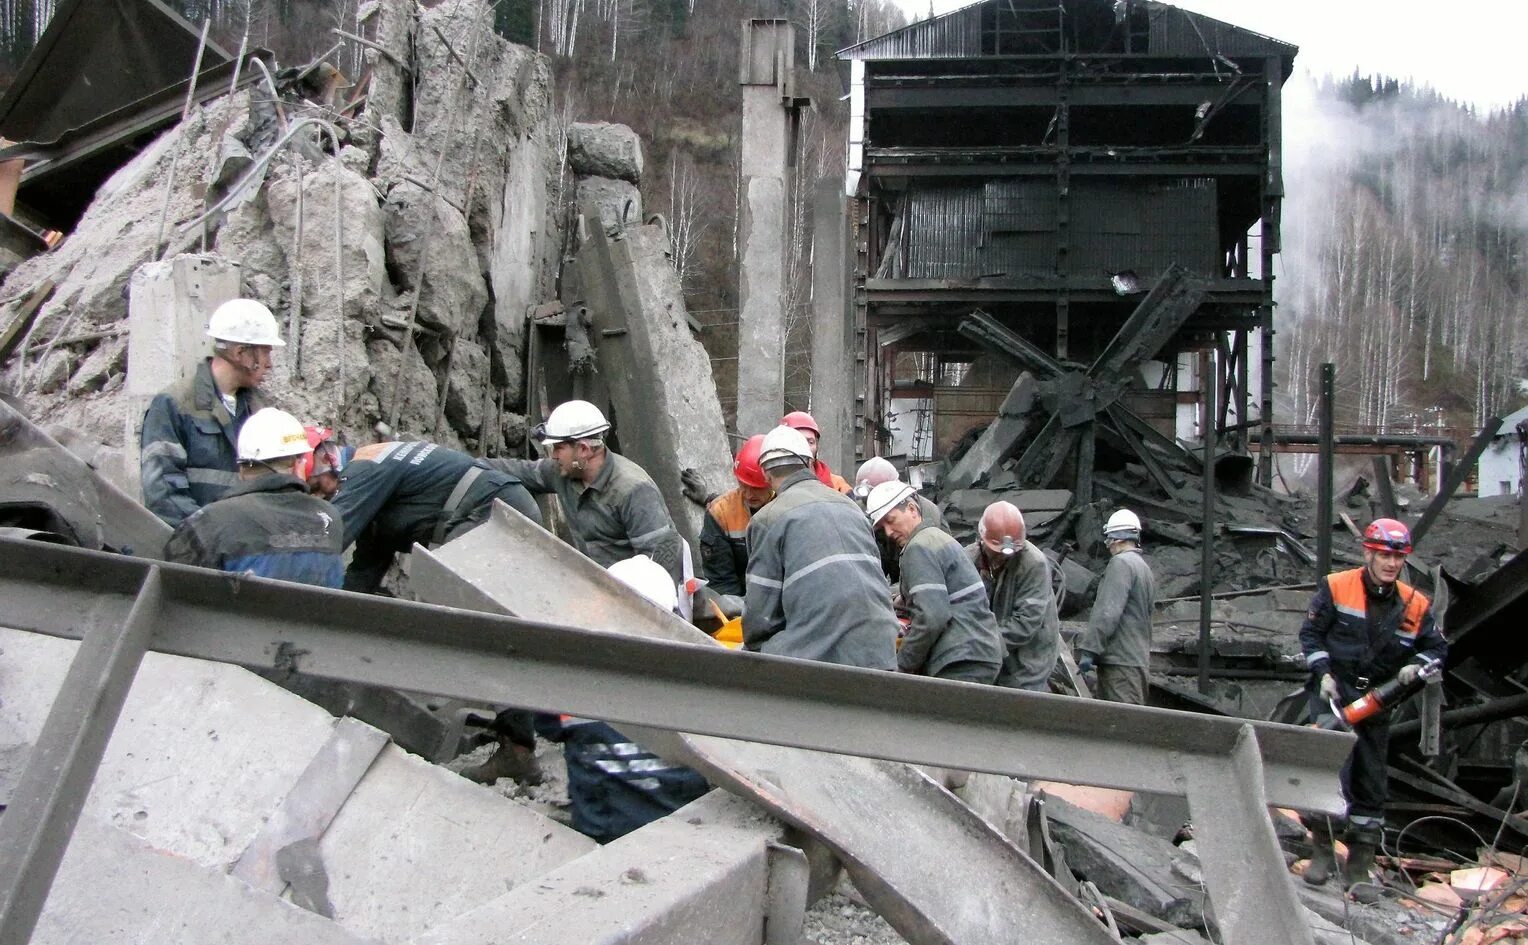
top-left (481, 450), bottom-right (685, 584)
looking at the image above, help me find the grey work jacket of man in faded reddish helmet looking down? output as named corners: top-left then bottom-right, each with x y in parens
top-left (966, 541), bottom-right (1060, 693)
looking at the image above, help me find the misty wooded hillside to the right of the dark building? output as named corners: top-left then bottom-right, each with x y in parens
top-left (1276, 75), bottom-right (1528, 430)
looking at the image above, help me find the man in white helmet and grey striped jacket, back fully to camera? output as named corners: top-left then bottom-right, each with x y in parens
top-left (743, 425), bottom-right (897, 670)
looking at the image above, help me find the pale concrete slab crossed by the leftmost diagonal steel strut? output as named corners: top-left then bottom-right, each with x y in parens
top-left (0, 630), bottom-right (335, 870)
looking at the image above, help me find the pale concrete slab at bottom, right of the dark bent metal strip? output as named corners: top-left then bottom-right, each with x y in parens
top-left (319, 745), bottom-right (597, 942)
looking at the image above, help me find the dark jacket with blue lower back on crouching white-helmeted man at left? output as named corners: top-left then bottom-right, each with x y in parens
top-left (165, 473), bottom-right (344, 587)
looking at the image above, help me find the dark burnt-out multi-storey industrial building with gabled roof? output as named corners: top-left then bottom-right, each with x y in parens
top-left (839, 0), bottom-right (1296, 482)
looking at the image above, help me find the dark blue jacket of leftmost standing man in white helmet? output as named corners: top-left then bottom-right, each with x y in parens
top-left (139, 358), bottom-right (266, 526)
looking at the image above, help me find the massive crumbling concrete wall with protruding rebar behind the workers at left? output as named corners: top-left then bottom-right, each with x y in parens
top-left (0, 0), bottom-right (562, 470)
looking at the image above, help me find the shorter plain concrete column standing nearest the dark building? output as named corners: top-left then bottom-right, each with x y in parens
top-left (811, 177), bottom-right (854, 479)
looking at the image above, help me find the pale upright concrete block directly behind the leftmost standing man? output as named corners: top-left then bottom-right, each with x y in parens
top-left (122, 254), bottom-right (243, 495)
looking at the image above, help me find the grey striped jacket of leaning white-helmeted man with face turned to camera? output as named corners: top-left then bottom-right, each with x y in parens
top-left (897, 521), bottom-right (1002, 682)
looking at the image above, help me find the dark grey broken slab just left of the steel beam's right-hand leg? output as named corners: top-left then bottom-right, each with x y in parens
top-left (1045, 798), bottom-right (1204, 928)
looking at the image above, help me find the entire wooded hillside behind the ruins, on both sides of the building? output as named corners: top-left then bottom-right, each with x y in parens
top-left (0, 0), bottom-right (1528, 428)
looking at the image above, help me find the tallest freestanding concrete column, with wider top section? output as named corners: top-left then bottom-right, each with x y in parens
top-left (738, 20), bottom-right (796, 436)
